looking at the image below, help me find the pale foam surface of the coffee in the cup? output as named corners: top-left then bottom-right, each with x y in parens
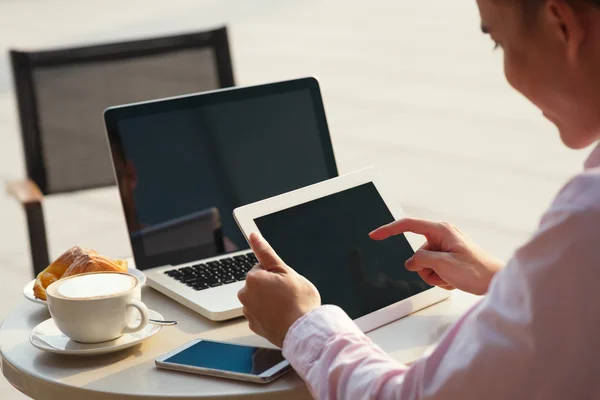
top-left (52, 273), bottom-right (137, 299)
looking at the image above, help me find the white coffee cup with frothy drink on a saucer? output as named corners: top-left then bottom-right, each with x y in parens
top-left (46, 272), bottom-right (148, 343)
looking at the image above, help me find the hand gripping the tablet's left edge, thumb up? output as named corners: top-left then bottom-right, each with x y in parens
top-left (238, 233), bottom-right (321, 347)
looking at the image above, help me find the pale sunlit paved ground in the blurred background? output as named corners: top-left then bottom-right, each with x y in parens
top-left (0, 0), bottom-right (585, 400)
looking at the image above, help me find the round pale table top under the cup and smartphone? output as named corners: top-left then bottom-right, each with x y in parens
top-left (0, 280), bottom-right (478, 400)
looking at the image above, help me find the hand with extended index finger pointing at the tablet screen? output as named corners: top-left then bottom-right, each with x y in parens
top-left (369, 218), bottom-right (504, 295)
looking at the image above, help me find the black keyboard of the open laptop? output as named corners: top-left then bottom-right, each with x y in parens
top-left (165, 253), bottom-right (258, 291)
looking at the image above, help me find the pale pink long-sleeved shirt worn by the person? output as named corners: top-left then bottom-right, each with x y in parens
top-left (283, 145), bottom-right (600, 400)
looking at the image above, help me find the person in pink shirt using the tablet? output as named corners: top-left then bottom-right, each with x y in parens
top-left (239, 0), bottom-right (600, 399)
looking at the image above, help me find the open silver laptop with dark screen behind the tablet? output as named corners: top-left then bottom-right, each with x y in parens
top-left (104, 78), bottom-right (338, 321)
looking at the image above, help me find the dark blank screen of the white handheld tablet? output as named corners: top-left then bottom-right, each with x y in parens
top-left (254, 183), bottom-right (431, 319)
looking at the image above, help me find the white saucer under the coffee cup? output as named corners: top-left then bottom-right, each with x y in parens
top-left (29, 310), bottom-right (164, 356)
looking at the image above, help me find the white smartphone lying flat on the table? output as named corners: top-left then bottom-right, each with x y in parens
top-left (156, 339), bottom-right (292, 383)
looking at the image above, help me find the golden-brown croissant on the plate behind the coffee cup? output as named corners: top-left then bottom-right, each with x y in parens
top-left (33, 246), bottom-right (127, 300)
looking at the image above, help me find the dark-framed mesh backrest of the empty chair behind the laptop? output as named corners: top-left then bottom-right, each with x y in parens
top-left (10, 27), bottom-right (234, 194)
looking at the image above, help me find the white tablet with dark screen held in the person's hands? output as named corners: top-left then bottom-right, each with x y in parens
top-left (234, 168), bottom-right (450, 332)
